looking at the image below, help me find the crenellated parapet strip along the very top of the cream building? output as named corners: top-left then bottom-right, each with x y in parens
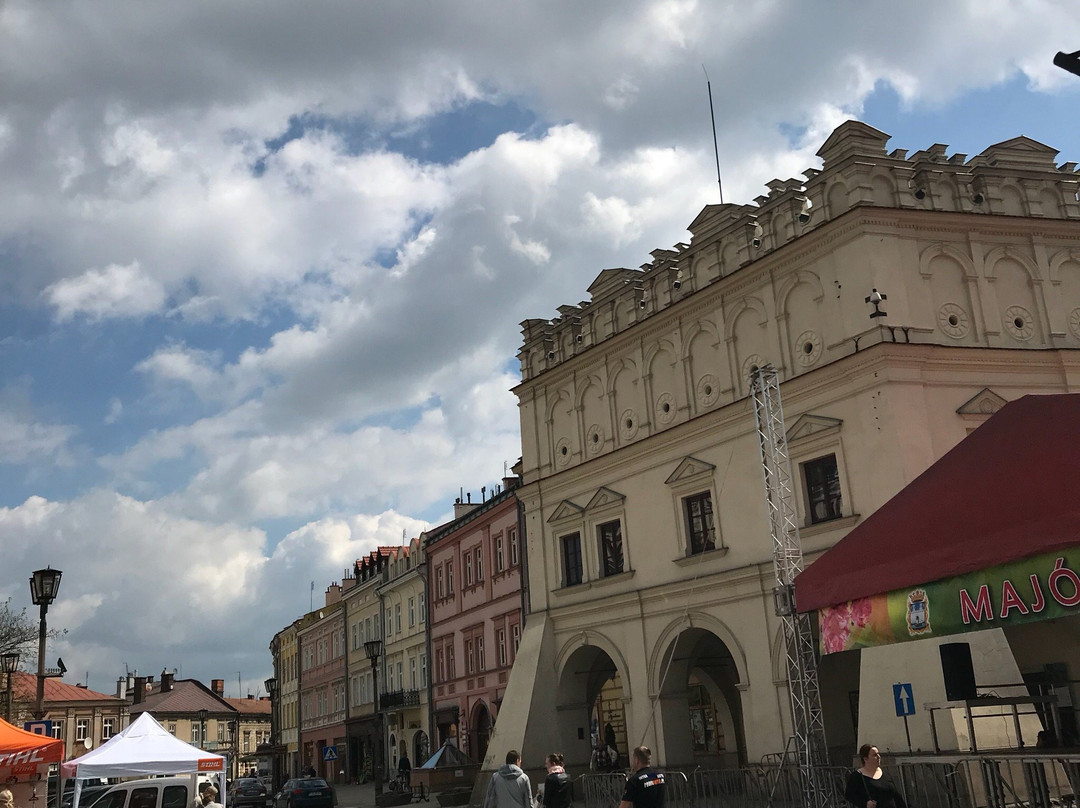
top-left (518, 121), bottom-right (1080, 381)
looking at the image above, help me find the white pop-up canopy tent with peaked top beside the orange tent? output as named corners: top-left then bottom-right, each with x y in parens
top-left (70, 713), bottom-right (225, 808)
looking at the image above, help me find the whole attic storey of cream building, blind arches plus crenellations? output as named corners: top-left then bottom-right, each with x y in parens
top-left (516, 121), bottom-right (1080, 477)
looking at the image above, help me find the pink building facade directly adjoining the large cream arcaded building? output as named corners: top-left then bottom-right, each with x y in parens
top-left (426, 479), bottom-right (523, 763)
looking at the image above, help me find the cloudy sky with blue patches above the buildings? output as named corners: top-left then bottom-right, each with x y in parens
top-left (0, 0), bottom-right (1080, 696)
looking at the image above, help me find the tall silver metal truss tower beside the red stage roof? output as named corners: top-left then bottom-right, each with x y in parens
top-left (751, 365), bottom-right (833, 808)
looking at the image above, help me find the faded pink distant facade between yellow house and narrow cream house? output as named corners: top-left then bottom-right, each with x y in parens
top-left (296, 596), bottom-right (347, 783)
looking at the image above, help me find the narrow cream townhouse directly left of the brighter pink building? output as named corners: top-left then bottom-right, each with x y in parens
top-left (378, 539), bottom-right (432, 772)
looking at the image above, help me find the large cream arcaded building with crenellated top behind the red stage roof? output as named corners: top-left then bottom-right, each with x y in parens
top-left (494, 121), bottom-right (1080, 769)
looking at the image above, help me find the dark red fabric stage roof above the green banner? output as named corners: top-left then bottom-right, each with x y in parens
top-left (795, 394), bottom-right (1080, 611)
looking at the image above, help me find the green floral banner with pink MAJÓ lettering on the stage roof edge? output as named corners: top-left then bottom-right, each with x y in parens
top-left (818, 546), bottom-right (1080, 654)
